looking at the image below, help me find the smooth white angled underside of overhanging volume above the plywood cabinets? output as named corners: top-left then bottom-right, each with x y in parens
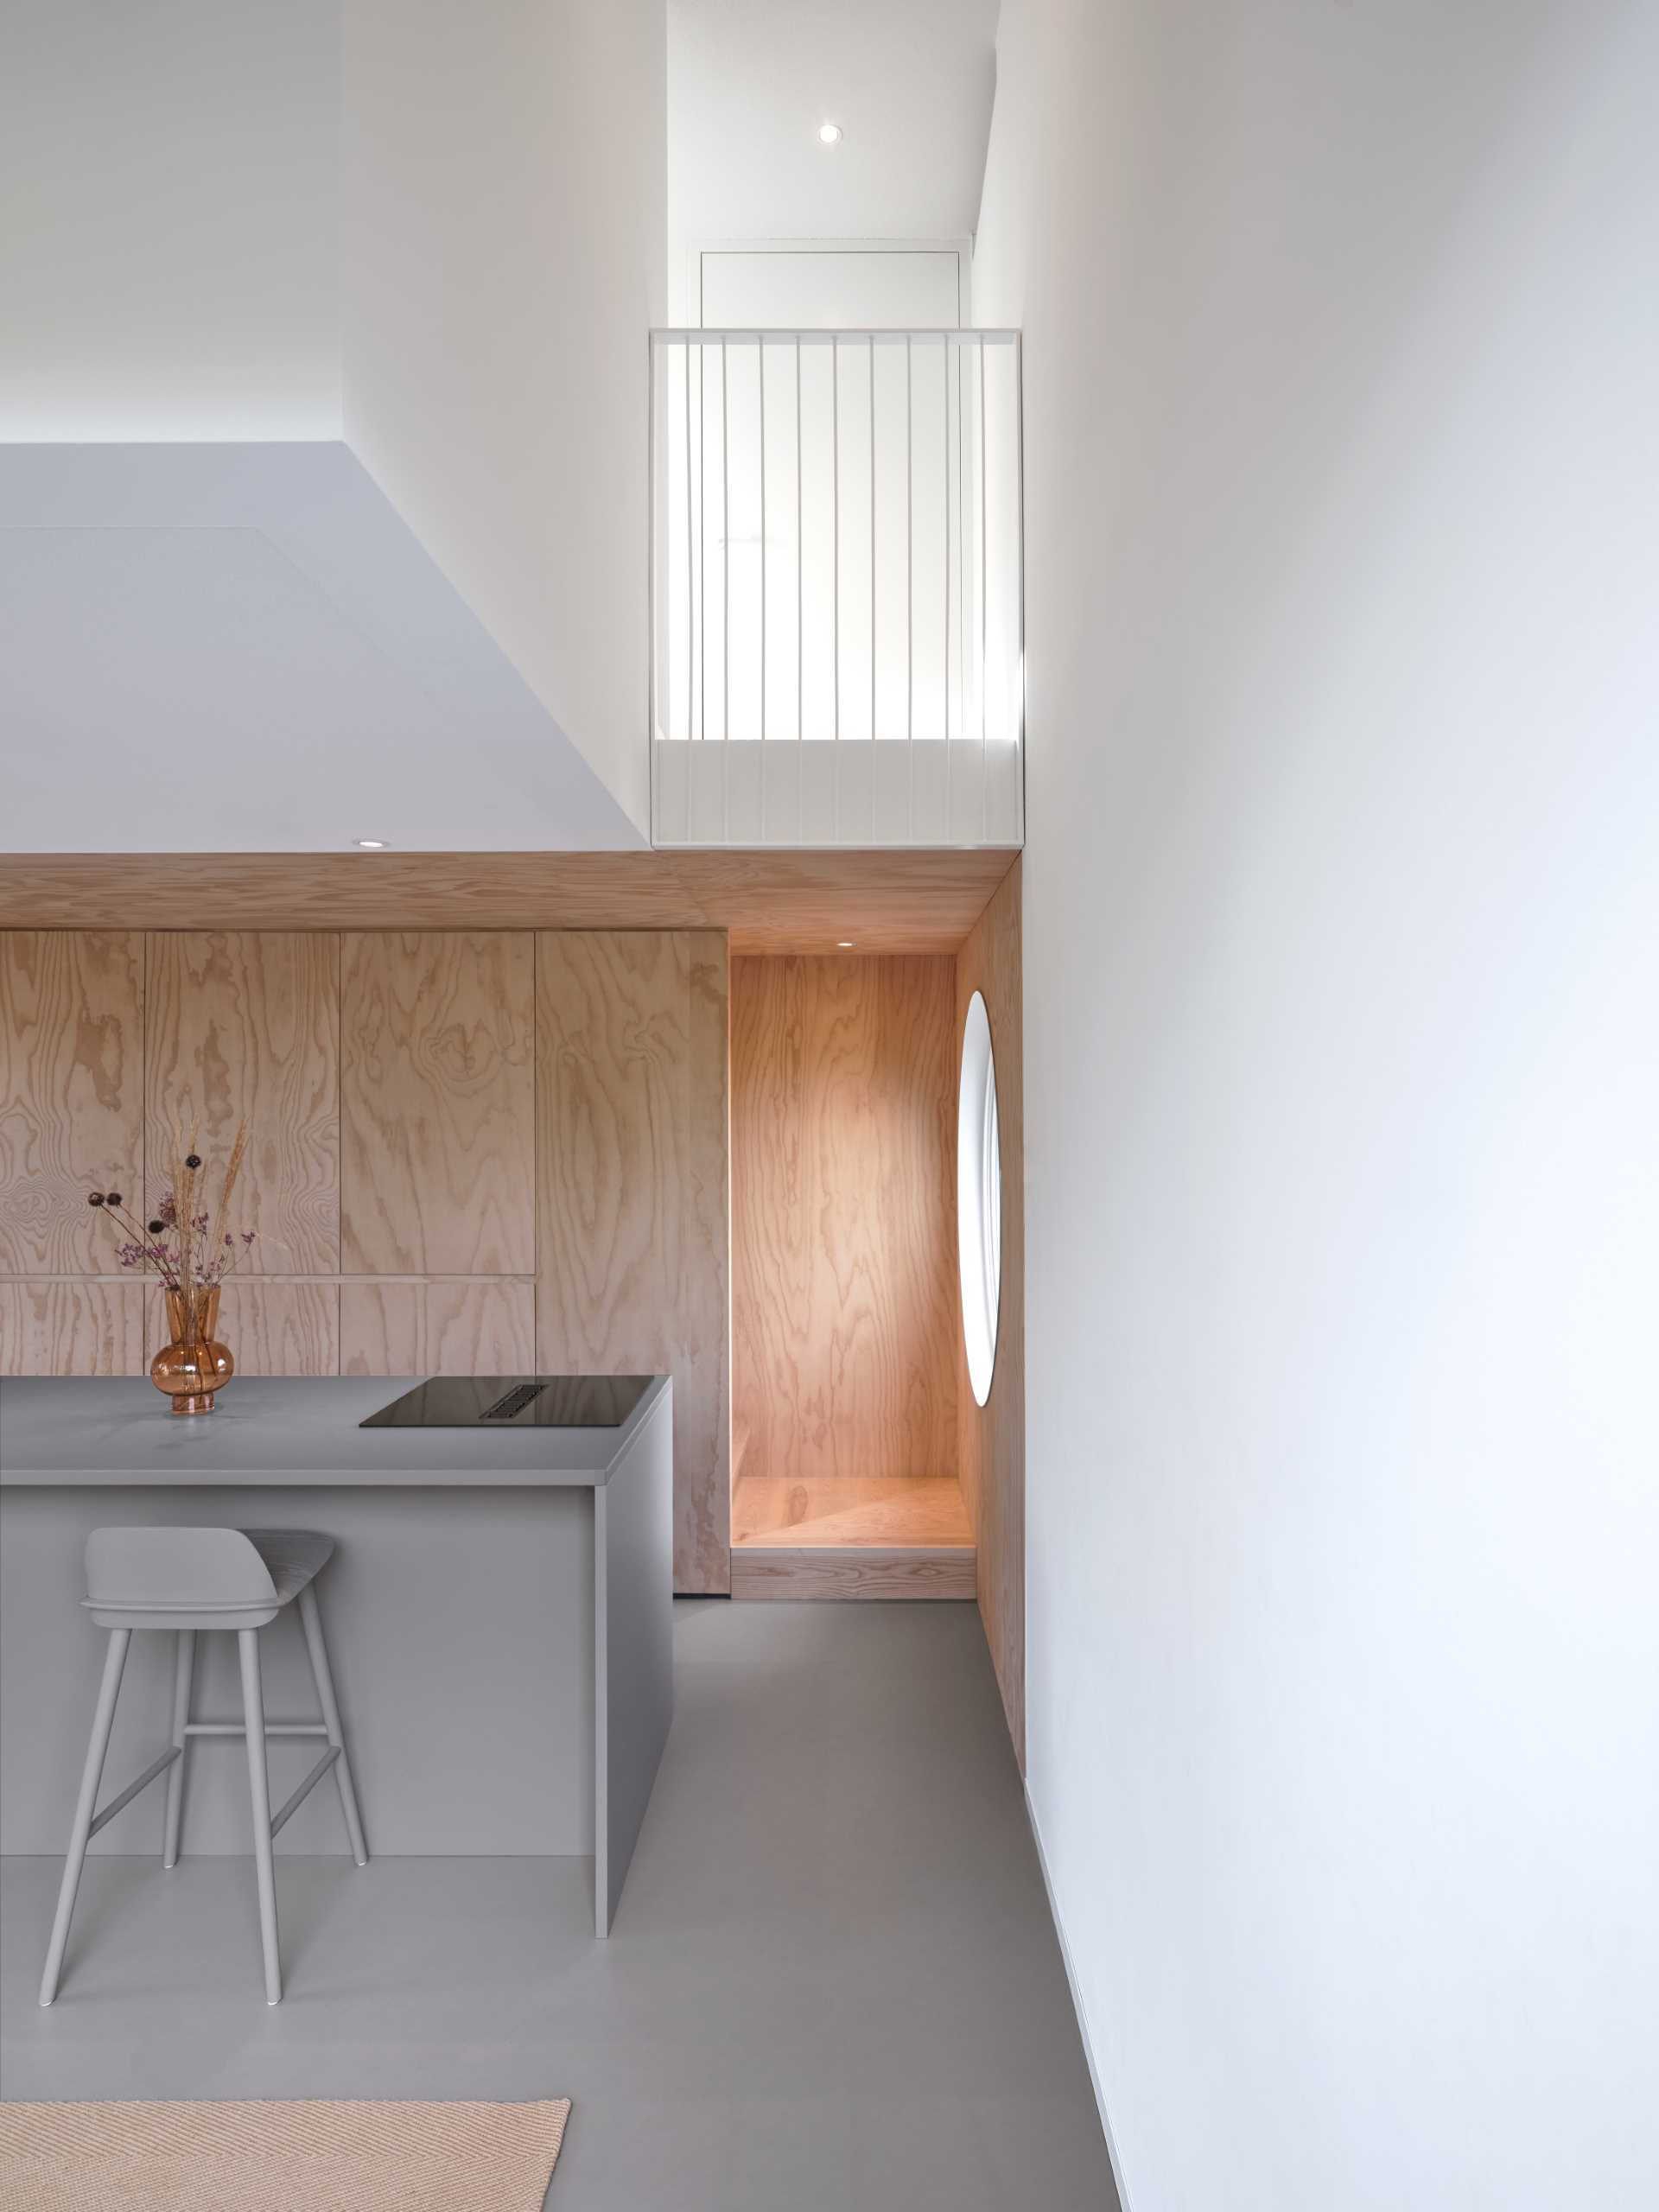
top-left (0, 442), bottom-right (644, 852)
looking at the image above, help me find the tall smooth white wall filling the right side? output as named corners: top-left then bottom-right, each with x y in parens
top-left (976, 0), bottom-right (1659, 2212)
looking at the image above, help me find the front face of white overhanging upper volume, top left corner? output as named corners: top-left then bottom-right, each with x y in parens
top-left (0, 0), bottom-right (340, 442)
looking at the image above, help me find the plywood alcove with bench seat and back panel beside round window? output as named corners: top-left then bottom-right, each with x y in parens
top-left (732, 953), bottom-right (973, 1597)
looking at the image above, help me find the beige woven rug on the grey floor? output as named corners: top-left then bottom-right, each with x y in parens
top-left (0, 2097), bottom-right (570, 2212)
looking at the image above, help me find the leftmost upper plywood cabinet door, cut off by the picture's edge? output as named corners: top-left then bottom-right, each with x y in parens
top-left (0, 929), bottom-right (143, 1282)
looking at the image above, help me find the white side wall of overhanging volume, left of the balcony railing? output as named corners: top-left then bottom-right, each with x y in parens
top-left (340, 0), bottom-right (666, 832)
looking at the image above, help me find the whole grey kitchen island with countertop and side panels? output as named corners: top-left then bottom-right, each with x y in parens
top-left (0, 1376), bottom-right (672, 1940)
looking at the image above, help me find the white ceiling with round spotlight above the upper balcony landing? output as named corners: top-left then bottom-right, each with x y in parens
top-left (668, 0), bottom-right (1000, 241)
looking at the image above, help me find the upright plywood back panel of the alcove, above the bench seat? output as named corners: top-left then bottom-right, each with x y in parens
top-left (732, 957), bottom-right (957, 1482)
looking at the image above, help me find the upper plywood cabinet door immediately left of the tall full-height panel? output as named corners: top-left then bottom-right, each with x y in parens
top-left (340, 929), bottom-right (536, 1282)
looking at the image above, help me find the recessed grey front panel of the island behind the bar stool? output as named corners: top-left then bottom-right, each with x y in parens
top-left (0, 1484), bottom-right (597, 1856)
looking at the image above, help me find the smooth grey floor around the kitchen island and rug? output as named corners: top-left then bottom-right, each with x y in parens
top-left (0, 1599), bottom-right (1117, 2212)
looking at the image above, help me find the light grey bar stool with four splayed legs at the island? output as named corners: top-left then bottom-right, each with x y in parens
top-left (40, 1529), bottom-right (370, 2004)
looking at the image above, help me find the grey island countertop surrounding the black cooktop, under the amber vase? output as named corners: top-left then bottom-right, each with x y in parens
top-left (0, 1376), bottom-right (668, 1489)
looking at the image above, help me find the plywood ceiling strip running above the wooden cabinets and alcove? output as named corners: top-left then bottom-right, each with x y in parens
top-left (0, 849), bottom-right (1013, 953)
